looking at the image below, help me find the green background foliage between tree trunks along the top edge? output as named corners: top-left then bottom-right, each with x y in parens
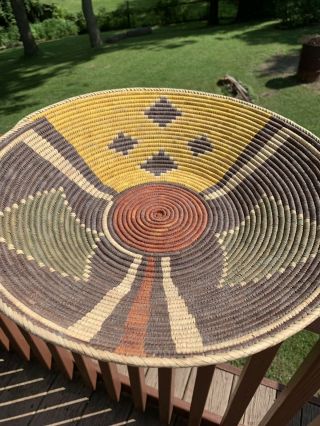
top-left (0, 0), bottom-right (320, 48)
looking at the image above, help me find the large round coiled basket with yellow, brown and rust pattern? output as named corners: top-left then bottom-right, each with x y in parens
top-left (0, 89), bottom-right (320, 367)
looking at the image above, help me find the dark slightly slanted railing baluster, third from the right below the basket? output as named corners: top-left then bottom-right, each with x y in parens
top-left (188, 365), bottom-right (215, 426)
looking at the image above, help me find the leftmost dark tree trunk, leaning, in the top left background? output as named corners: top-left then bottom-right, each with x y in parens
top-left (10, 0), bottom-right (38, 56)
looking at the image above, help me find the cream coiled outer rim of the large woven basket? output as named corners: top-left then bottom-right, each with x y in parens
top-left (0, 87), bottom-right (320, 368)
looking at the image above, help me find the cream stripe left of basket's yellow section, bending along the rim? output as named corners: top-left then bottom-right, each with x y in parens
top-left (0, 129), bottom-right (113, 201)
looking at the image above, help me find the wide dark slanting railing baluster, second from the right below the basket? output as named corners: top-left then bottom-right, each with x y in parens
top-left (221, 345), bottom-right (280, 426)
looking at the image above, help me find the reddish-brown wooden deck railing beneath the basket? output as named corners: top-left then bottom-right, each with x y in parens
top-left (0, 315), bottom-right (320, 426)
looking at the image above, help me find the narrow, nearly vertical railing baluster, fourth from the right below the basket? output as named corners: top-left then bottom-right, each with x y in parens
top-left (158, 368), bottom-right (175, 424)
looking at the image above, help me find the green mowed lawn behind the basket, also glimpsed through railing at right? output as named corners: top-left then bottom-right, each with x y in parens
top-left (0, 22), bottom-right (320, 383)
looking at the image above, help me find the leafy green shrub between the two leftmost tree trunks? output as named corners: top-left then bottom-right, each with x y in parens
top-left (31, 18), bottom-right (78, 40)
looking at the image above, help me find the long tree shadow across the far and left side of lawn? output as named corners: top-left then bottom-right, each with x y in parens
top-left (0, 22), bottom-right (310, 126)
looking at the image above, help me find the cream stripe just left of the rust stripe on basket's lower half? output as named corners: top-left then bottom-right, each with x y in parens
top-left (68, 258), bottom-right (141, 342)
